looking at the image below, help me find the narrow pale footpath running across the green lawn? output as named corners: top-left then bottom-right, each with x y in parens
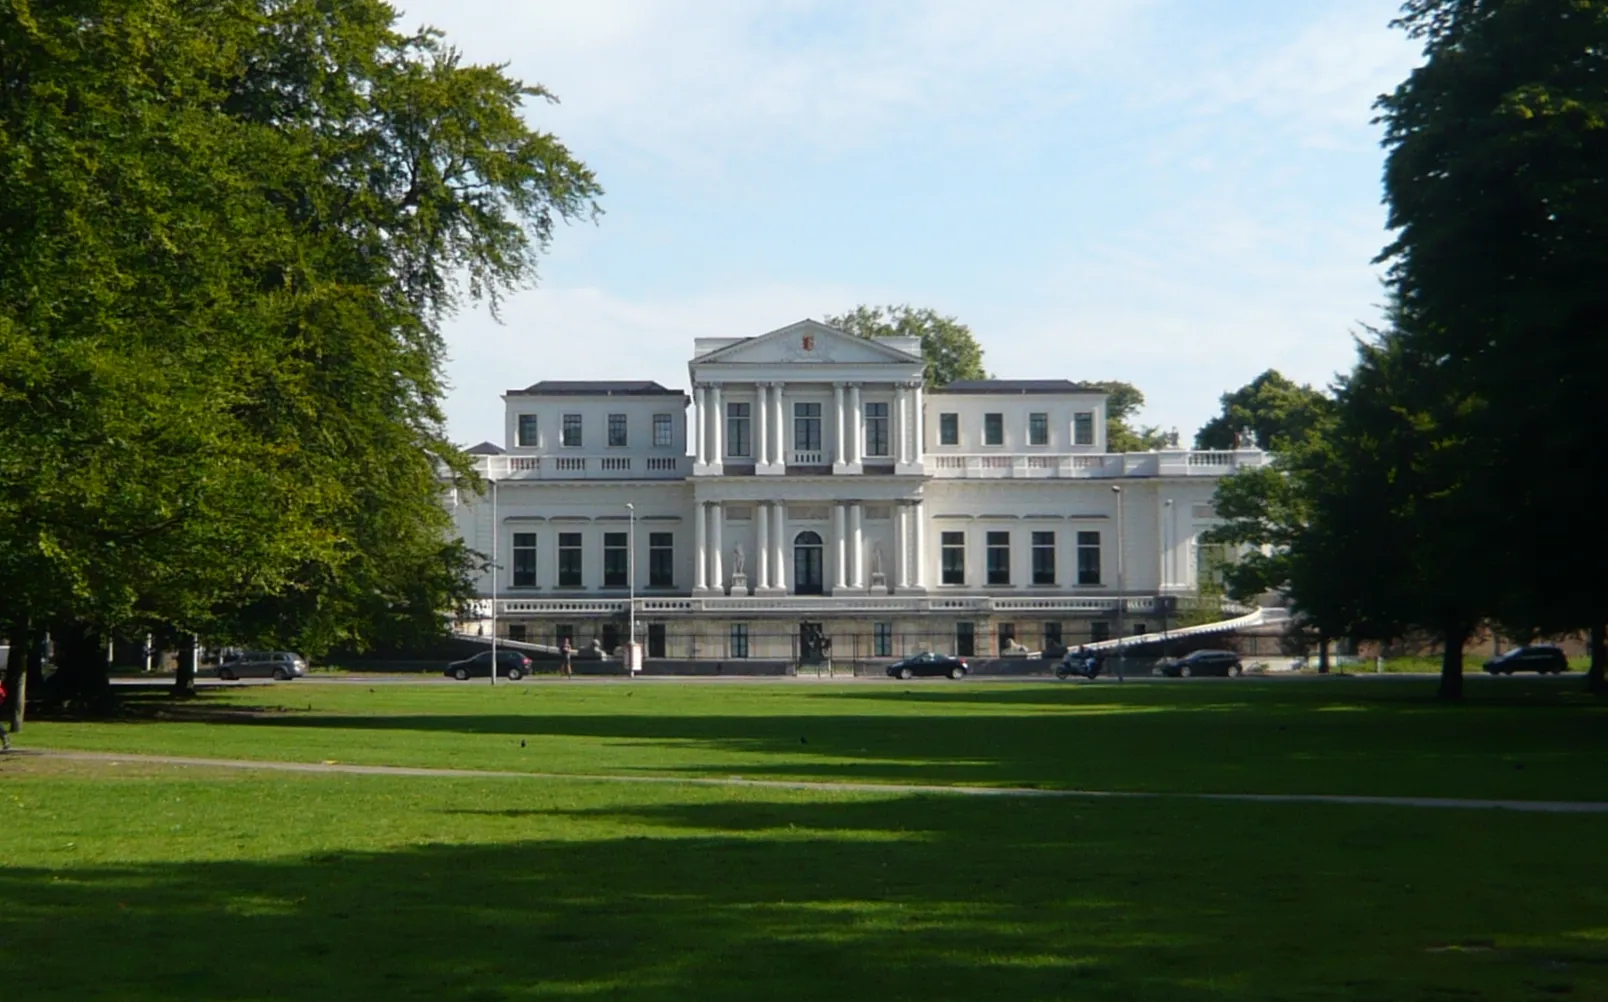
top-left (22, 749), bottom-right (1608, 814)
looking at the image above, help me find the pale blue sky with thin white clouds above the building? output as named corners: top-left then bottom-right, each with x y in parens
top-left (400, 0), bottom-right (1418, 444)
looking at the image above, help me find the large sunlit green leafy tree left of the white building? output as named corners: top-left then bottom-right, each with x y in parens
top-left (0, 0), bottom-right (598, 704)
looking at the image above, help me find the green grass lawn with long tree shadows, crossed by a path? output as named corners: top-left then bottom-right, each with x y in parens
top-left (0, 679), bottom-right (1608, 1002)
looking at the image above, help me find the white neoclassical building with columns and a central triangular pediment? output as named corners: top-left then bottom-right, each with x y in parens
top-left (450, 320), bottom-right (1267, 659)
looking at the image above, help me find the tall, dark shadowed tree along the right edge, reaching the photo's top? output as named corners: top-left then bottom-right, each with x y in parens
top-left (1381, 0), bottom-right (1608, 687)
